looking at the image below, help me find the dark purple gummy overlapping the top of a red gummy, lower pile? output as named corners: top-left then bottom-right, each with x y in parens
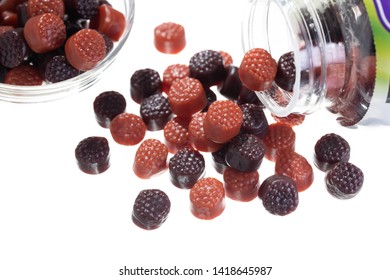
top-left (225, 133), bottom-right (265, 172)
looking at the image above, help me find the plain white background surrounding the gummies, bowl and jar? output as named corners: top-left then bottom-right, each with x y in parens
top-left (0, 0), bottom-right (390, 280)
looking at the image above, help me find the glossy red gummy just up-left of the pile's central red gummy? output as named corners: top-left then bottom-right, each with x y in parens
top-left (168, 77), bottom-right (207, 118)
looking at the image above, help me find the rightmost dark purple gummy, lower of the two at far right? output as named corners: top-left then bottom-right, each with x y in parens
top-left (325, 162), bottom-right (364, 199)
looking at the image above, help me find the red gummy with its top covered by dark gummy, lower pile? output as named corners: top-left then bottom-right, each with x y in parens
top-left (223, 167), bottom-right (260, 202)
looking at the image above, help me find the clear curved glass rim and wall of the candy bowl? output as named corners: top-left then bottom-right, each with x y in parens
top-left (0, 0), bottom-right (135, 103)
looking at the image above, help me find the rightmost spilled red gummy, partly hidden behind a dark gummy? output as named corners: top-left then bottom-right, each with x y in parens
top-left (275, 151), bottom-right (314, 192)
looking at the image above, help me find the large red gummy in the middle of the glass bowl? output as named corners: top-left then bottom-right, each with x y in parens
top-left (24, 13), bottom-right (66, 53)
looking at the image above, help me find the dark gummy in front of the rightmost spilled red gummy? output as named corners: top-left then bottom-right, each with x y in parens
top-left (258, 175), bottom-right (299, 216)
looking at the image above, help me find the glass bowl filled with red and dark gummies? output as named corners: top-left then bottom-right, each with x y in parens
top-left (0, 0), bottom-right (135, 103)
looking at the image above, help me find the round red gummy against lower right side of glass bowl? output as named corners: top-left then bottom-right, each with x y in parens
top-left (65, 29), bottom-right (106, 71)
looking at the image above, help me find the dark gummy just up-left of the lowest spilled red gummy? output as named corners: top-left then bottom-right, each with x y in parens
top-left (169, 148), bottom-right (205, 189)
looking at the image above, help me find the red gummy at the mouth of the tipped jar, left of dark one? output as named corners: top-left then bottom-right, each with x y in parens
top-left (238, 48), bottom-right (277, 91)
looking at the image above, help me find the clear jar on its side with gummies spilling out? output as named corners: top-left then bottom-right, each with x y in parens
top-left (242, 0), bottom-right (390, 126)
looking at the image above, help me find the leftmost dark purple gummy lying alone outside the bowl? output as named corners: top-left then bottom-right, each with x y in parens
top-left (75, 136), bottom-right (110, 174)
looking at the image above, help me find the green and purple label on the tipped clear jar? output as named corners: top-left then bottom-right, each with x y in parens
top-left (363, 0), bottom-right (390, 124)
